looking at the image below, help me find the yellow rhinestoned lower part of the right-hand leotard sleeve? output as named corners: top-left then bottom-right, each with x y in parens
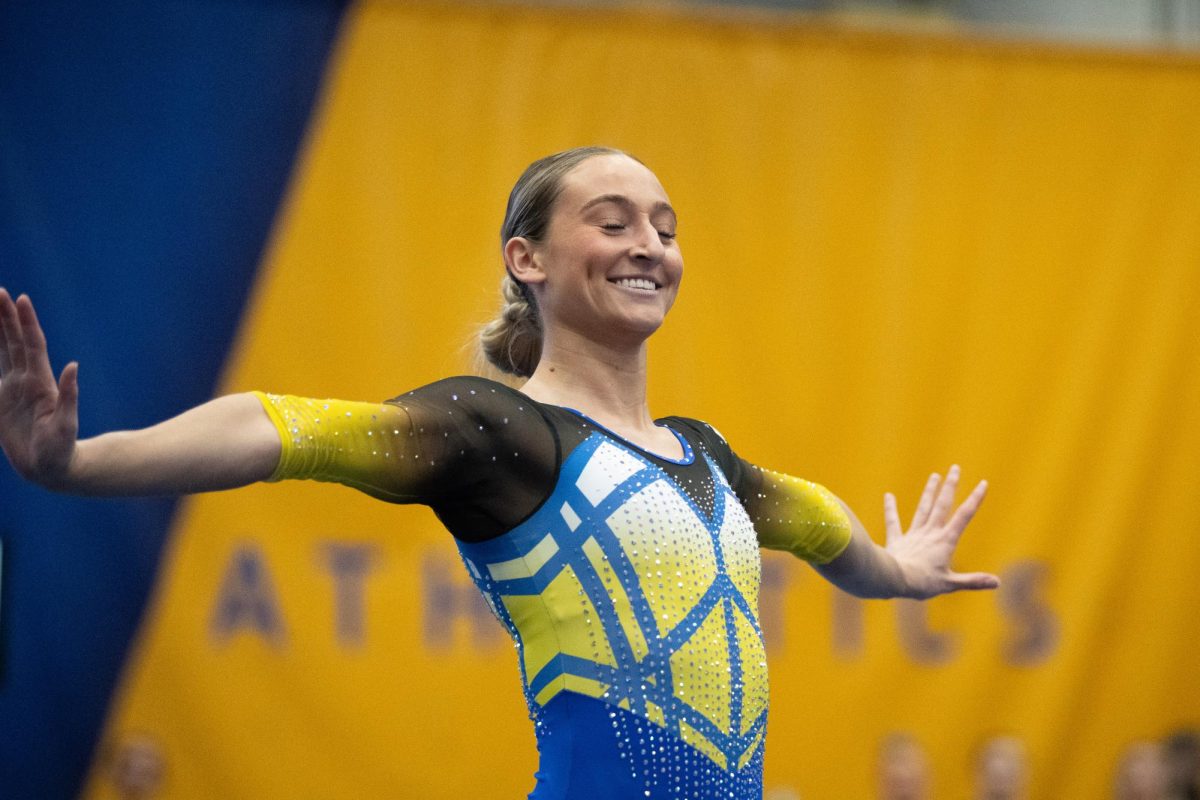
top-left (752, 470), bottom-right (851, 564)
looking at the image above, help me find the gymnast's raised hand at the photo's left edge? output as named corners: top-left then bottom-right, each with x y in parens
top-left (0, 288), bottom-right (79, 488)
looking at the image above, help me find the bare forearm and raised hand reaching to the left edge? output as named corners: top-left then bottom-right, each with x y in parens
top-left (0, 289), bottom-right (281, 495)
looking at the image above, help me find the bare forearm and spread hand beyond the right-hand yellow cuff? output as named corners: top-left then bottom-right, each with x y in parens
top-left (816, 465), bottom-right (1000, 600)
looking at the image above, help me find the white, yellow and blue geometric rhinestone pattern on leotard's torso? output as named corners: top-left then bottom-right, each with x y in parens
top-left (458, 433), bottom-right (768, 798)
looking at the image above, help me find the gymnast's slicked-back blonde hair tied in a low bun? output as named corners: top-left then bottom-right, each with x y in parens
top-left (479, 146), bottom-right (641, 378)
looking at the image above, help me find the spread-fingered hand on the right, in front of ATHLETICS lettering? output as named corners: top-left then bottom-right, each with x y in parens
top-left (883, 464), bottom-right (1000, 600)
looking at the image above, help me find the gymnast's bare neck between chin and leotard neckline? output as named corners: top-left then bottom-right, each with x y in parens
top-left (521, 329), bottom-right (654, 429)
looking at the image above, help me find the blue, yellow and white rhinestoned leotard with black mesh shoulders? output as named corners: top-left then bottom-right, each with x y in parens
top-left (259, 378), bottom-right (850, 800)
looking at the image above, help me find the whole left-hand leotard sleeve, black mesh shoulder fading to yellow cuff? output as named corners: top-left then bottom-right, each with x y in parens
top-left (256, 377), bottom-right (559, 541)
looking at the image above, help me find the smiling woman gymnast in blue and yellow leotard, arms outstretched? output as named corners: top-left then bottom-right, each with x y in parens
top-left (0, 148), bottom-right (997, 800)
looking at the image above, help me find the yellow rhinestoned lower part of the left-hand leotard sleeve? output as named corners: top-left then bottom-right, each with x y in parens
top-left (254, 392), bottom-right (421, 503)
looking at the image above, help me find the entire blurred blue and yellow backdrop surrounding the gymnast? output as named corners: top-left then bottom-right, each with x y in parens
top-left (0, 0), bottom-right (1200, 800)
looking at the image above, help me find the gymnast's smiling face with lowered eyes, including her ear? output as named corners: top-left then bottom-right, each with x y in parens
top-left (505, 155), bottom-right (683, 344)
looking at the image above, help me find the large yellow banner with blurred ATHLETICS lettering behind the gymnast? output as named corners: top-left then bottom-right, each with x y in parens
top-left (85, 2), bottom-right (1200, 800)
